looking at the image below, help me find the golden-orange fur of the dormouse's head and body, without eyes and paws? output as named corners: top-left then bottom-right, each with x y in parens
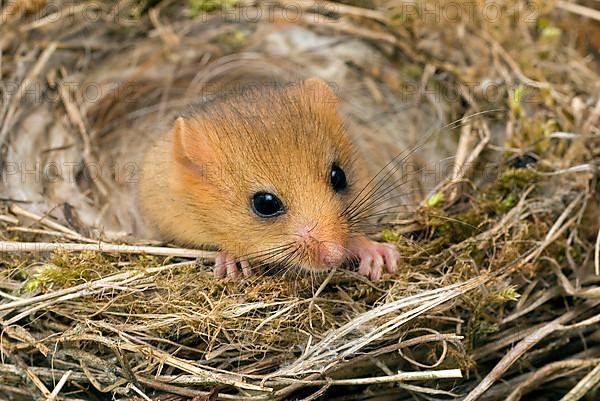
top-left (139, 80), bottom-right (367, 270)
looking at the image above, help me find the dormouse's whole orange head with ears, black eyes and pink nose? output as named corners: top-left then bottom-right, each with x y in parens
top-left (172, 79), bottom-right (367, 271)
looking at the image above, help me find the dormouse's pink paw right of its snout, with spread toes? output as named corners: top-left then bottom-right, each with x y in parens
top-left (349, 236), bottom-right (400, 281)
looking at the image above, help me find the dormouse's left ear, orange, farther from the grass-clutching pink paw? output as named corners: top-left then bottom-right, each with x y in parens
top-left (172, 117), bottom-right (212, 174)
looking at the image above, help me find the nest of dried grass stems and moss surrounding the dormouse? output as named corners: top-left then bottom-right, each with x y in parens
top-left (0, 1), bottom-right (600, 401)
